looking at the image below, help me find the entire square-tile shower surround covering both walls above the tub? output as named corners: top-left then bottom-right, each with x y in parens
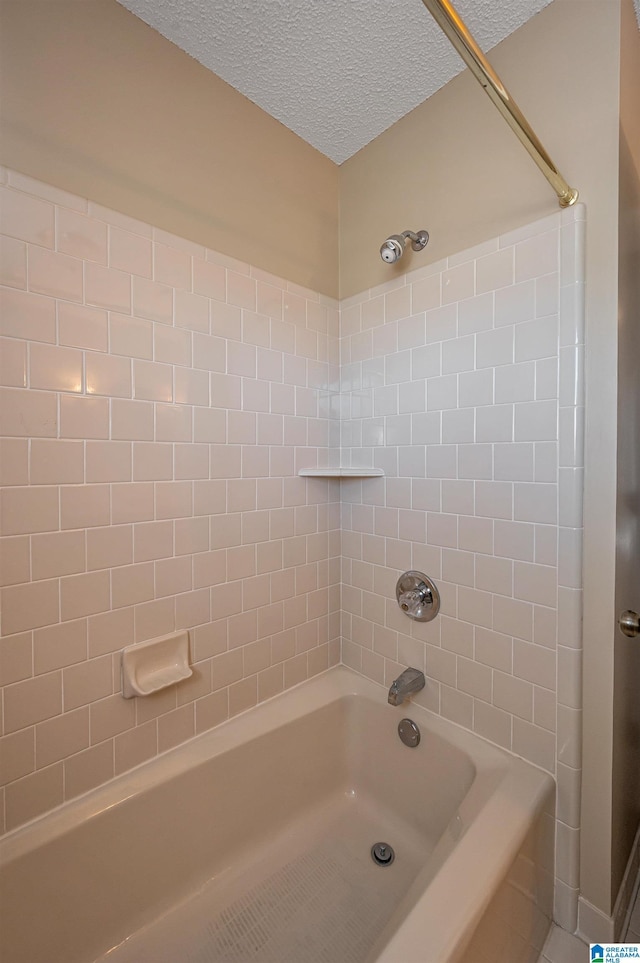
top-left (0, 172), bottom-right (584, 930)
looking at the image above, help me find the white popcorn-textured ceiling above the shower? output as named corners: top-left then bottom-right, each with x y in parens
top-left (119, 0), bottom-right (550, 164)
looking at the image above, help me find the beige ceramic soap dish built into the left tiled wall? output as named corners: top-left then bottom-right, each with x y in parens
top-left (122, 632), bottom-right (193, 699)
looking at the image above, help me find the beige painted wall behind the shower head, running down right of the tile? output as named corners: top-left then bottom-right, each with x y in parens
top-left (340, 0), bottom-right (620, 914)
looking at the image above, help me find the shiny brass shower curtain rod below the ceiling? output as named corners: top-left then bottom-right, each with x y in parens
top-left (422, 0), bottom-right (578, 207)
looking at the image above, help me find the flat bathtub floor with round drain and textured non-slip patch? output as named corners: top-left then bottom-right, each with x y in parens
top-left (96, 795), bottom-right (435, 963)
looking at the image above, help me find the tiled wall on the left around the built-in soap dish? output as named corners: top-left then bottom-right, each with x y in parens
top-left (0, 171), bottom-right (340, 829)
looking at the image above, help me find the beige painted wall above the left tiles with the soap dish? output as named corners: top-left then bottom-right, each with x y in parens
top-left (0, 0), bottom-right (338, 297)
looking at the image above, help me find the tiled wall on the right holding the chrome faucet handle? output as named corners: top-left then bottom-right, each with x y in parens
top-left (341, 208), bottom-right (584, 931)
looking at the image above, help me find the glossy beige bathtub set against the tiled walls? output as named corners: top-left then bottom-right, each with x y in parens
top-left (0, 666), bottom-right (553, 963)
